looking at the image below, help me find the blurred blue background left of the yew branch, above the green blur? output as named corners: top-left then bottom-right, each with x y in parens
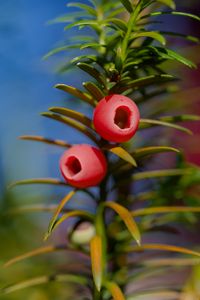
top-left (0, 0), bottom-right (96, 202)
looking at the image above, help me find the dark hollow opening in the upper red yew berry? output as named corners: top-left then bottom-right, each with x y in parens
top-left (114, 106), bottom-right (130, 129)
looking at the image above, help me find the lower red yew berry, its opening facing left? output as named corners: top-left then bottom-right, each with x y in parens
top-left (60, 144), bottom-right (107, 188)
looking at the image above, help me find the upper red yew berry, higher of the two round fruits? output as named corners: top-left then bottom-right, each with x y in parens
top-left (93, 94), bottom-right (140, 143)
